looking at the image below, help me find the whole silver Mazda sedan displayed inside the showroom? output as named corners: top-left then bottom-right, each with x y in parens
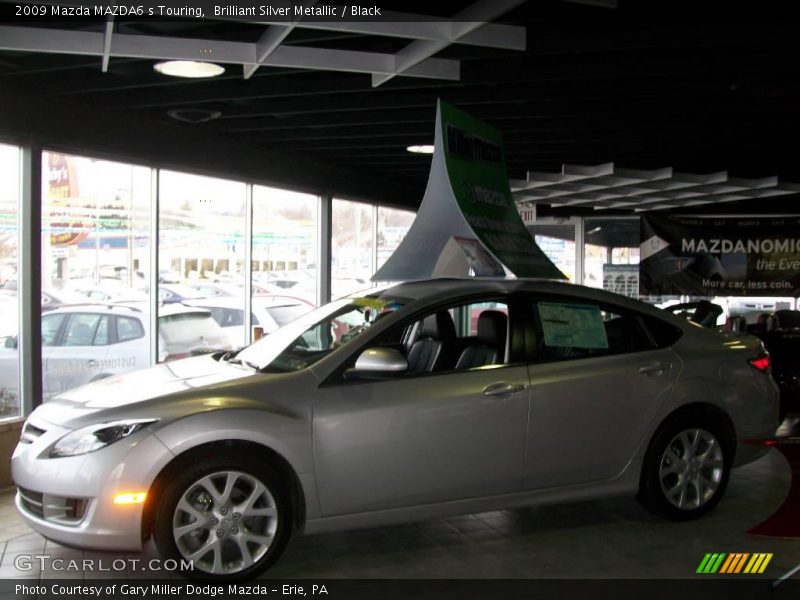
top-left (12, 279), bottom-right (778, 578)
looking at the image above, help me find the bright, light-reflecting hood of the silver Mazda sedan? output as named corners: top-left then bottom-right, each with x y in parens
top-left (35, 355), bottom-right (254, 426)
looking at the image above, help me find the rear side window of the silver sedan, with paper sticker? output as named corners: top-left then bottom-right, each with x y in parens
top-left (534, 299), bottom-right (654, 362)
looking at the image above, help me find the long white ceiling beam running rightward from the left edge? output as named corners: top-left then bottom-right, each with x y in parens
top-left (0, 26), bottom-right (460, 81)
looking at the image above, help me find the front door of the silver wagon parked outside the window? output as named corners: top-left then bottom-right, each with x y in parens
top-left (45, 312), bottom-right (109, 395)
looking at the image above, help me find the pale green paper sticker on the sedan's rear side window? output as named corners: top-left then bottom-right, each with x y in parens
top-left (538, 302), bottom-right (608, 349)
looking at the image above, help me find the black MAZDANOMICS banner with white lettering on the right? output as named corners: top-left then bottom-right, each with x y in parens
top-left (639, 217), bottom-right (800, 296)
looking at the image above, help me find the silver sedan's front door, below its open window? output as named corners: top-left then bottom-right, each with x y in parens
top-left (313, 298), bottom-right (528, 515)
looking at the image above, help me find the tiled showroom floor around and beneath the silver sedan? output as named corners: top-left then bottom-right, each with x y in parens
top-left (0, 450), bottom-right (800, 579)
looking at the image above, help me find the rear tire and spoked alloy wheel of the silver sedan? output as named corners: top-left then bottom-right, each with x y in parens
top-left (638, 414), bottom-right (735, 521)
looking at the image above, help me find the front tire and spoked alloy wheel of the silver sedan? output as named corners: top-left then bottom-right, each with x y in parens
top-left (153, 454), bottom-right (292, 580)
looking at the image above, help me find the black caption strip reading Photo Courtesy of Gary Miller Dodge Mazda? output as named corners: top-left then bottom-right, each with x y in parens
top-left (0, 576), bottom-right (800, 600)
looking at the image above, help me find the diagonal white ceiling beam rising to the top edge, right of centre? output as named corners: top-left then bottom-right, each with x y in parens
top-left (372, 0), bottom-right (525, 87)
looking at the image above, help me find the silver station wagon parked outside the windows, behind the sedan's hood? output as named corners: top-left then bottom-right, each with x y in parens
top-left (0, 304), bottom-right (230, 401)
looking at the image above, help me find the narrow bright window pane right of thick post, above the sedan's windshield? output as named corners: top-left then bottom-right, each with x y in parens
top-left (331, 198), bottom-right (377, 298)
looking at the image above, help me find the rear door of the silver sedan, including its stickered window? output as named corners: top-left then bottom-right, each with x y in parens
top-left (525, 298), bottom-right (681, 489)
